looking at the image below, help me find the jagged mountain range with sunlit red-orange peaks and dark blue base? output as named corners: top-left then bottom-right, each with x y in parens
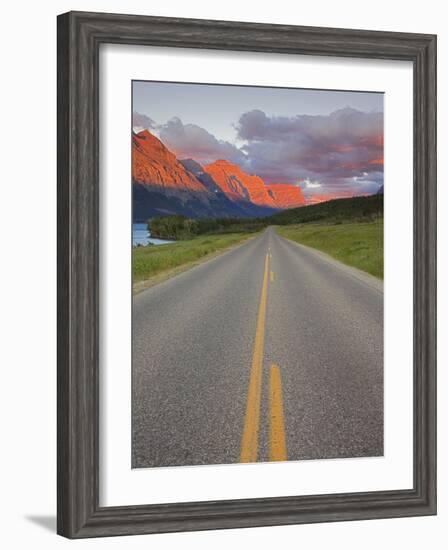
top-left (132, 130), bottom-right (305, 222)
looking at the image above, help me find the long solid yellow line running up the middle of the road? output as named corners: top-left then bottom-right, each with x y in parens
top-left (240, 254), bottom-right (269, 462)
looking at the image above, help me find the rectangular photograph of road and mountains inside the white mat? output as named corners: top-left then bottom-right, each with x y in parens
top-left (131, 80), bottom-right (384, 468)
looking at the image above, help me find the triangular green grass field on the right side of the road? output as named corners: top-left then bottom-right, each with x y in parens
top-left (277, 219), bottom-right (383, 279)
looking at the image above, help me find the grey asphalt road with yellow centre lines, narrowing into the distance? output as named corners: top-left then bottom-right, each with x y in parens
top-left (132, 228), bottom-right (383, 468)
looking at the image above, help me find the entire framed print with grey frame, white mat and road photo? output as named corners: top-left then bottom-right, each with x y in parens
top-left (58, 12), bottom-right (436, 538)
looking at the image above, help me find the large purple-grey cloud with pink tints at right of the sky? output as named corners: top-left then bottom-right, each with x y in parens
top-left (236, 108), bottom-right (383, 194)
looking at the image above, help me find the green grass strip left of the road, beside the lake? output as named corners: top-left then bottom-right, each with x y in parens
top-left (132, 233), bottom-right (251, 283)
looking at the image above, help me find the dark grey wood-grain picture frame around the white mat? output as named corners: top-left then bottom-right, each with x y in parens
top-left (57, 12), bottom-right (436, 538)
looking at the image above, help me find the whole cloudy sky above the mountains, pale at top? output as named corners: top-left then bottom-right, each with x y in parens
top-left (132, 81), bottom-right (383, 200)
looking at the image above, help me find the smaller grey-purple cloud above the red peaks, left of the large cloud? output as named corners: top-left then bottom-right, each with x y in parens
top-left (158, 117), bottom-right (246, 165)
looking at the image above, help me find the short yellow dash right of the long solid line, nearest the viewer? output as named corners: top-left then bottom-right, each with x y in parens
top-left (269, 364), bottom-right (288, 461)
